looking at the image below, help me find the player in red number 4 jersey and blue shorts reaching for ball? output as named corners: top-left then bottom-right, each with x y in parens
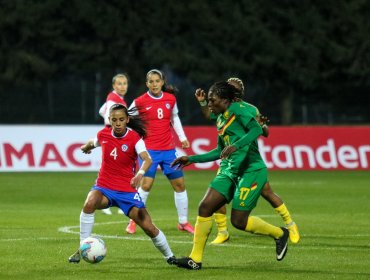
top-left (69, 104), bottom-right (176, 264)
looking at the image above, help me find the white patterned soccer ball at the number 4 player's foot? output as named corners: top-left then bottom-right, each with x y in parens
top-left (80, 237), bottom-right (107, 263)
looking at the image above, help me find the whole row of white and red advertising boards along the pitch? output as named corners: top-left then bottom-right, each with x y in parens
top-left (0, 125), bottom-right (370, 172)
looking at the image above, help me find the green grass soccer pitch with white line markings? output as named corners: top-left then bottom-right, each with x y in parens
top-left (0, 171), bottom-right (370, 280)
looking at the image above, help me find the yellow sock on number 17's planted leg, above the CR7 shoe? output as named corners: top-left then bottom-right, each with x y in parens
top-left (190, 216), bottom-right (213, 263)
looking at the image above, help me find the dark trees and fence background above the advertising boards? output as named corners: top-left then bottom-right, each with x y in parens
top-left (0, 0), bottom-right (370, 125)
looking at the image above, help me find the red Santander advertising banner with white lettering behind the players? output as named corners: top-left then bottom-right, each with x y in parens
top-left (177, 126), bottom-right (370, 170)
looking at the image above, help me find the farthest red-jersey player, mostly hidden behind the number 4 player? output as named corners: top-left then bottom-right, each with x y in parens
top-left (99, 74), bottom-right (129, 125)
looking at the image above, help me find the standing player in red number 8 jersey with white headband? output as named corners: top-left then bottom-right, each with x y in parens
top-left (126, 69), bottom-right (194, 233)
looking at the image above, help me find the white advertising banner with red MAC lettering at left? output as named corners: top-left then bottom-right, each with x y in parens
top-left (0, 125), bottom-right (102, 171)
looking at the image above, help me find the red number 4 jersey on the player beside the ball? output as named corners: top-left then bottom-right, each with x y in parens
top-left (96, 127), bottom-right (141, 192)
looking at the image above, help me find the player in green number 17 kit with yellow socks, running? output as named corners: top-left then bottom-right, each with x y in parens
top-left (173, 82), bottom-right (289, 269)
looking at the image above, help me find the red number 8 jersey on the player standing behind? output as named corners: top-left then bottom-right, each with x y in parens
top-left (133, 92), bottom-right (178, 151)
